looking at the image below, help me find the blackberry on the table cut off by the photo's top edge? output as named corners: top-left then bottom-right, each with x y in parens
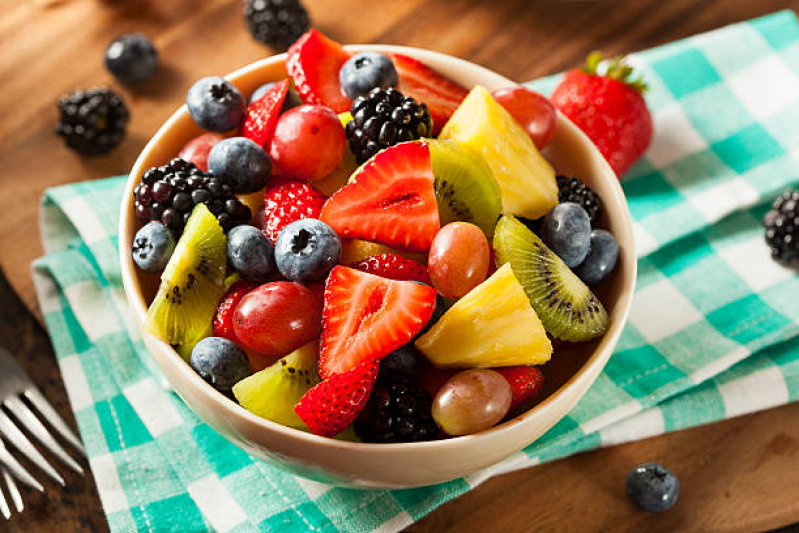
top-left (244, 0), bottom-right (311, 50)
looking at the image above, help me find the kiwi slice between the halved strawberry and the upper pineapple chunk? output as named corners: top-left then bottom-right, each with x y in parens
top-left (426, 140), bottom-right (502, 240)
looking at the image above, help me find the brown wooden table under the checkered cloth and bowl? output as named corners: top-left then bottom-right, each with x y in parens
top-left (0, 0), bottom-right (799, 532)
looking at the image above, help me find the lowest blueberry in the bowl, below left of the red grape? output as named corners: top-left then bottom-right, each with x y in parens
top-left (189, 337), bottom-right (250, 393)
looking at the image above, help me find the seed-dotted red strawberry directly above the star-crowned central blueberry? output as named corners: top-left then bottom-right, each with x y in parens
top-left (262, 180), bottom-right (327, 245)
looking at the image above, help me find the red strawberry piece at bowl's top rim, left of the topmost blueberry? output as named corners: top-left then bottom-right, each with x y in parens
top-left (286, 30), bottom-right (352, 113)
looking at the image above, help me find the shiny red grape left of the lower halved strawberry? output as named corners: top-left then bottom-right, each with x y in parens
top-left (233, 281), bottom-right (322, 357)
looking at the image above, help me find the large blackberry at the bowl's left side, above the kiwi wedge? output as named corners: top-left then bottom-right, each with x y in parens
top-left (133, 158), bottom-right (252, 236)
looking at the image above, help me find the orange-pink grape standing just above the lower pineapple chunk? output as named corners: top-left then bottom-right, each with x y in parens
top-left (427, 222), bottom-right (491, 299)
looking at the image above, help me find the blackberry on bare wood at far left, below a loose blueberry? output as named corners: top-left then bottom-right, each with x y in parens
top-left (55, 87), bottom-right (130, 155)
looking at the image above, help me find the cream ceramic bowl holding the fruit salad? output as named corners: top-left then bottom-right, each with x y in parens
top-left (119, 45), bottom-right (636, 488)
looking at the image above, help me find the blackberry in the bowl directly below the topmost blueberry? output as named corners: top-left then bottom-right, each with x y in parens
top-left (347, 87), bottom-right (433, 163)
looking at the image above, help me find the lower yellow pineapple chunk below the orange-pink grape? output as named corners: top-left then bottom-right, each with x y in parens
top-left (416, 264), bottom-right (552, 368)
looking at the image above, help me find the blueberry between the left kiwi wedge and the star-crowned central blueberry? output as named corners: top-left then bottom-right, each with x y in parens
top-left (227, 226), bottom-right (275, 283)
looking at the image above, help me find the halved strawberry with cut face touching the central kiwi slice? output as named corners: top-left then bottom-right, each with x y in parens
top-left (321, 141), bottom-right (441, 252)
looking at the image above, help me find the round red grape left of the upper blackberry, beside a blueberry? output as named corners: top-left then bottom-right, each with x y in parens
top-left (269, 105), bottom-right (347, 181)
